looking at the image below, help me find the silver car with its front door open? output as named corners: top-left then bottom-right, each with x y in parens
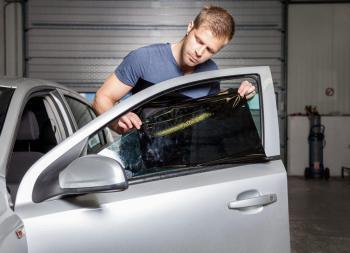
top-left (0, 67), bottom-right (290, 253)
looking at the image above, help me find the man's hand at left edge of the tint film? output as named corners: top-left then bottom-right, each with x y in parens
top-left (111, 112), bottom-right (142, 134)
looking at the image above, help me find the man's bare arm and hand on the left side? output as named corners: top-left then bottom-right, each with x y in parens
top-left (92, 73), bottom-right (142, 134)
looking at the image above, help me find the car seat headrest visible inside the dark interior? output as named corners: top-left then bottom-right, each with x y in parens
top-left (17, 111), bottom-right (39, 141)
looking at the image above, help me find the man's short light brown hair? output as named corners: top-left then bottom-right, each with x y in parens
top-left (194, 5), bottom-right (235, 41)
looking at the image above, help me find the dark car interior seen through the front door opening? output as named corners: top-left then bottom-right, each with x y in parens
top-left (6, 97), bottom-right (58, 201)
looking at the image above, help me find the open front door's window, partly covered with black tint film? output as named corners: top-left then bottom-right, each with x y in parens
top-left (93, 76), bottom-right (265, 178)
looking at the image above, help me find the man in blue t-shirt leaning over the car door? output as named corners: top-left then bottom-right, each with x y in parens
top-left (93, 6), bottom-right (255, 134)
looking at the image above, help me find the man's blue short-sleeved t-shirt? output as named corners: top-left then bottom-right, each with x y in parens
top-left (115, 43), bottom-right (218, 98)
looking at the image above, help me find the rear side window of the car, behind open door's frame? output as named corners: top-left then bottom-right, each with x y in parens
top-left (65, 96), bottom-right (106, 154)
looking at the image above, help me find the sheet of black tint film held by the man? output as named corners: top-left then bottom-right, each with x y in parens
top-left (138, 89), bottom-right (263, 170)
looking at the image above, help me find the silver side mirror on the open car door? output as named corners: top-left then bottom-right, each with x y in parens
top-left (58, 155), bottom-right (128, 195)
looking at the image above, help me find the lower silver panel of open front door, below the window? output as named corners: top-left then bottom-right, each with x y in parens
top-left (16, 161), bottom-right (289, 253)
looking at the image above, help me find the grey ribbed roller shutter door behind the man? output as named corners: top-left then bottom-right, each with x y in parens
top-left (26, 0), bottom-right (283, 93)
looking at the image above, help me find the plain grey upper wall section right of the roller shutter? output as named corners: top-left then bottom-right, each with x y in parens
top-left (288, 3), bottom-right (350, 115)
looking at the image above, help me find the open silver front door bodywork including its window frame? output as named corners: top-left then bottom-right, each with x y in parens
top-left (16, 68), bottom-right (290, 253)
